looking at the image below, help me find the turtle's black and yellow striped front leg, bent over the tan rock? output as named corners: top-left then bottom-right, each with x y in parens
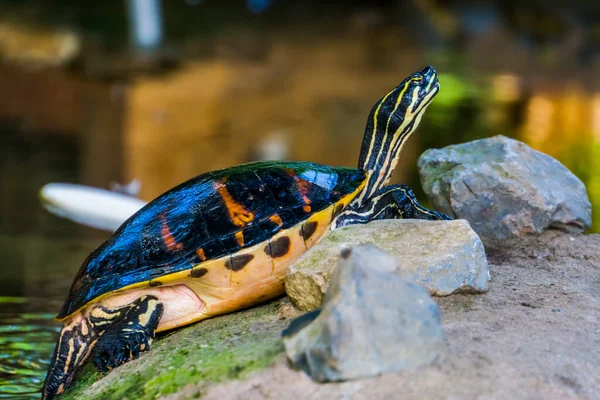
top-left (332, 185), bottom-right (452, 229)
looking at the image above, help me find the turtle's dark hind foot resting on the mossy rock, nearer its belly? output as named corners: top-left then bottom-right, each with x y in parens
top-left (92, 296), bottom-right (163, 372)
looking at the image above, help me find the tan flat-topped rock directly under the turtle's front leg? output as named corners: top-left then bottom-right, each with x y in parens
top-left (285, 220), bottom-right (490, 311)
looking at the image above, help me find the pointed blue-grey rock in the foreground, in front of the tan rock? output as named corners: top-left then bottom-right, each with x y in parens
top-left (284, 245), bottom-right (445, 381)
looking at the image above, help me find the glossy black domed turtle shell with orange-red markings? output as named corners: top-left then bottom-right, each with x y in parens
top-left (57, 161), bottom-right (366, 319)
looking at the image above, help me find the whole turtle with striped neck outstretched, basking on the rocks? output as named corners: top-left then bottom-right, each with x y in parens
top-left (42, 66), bottom-right (450, 399)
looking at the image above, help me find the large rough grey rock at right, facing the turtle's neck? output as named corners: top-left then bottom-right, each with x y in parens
top-left (419, 136), bottom-right (592, 239)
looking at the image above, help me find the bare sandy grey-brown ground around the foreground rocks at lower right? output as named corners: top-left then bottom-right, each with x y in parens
top-left (168, 232), bottom-right (600, 400)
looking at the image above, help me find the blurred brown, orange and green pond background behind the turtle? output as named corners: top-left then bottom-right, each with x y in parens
top-left (0, 0), bottom-right (600, 398)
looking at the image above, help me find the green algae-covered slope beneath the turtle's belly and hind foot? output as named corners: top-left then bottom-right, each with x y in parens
top-left (61, 301), bottom-right (286, 400)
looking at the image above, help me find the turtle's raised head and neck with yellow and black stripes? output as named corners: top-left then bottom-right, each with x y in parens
top-left (358, 66), bottom-right (440, 201)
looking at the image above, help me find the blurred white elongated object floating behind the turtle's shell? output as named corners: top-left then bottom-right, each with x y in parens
top-left (40, 183), bottom-right (146, 232)
